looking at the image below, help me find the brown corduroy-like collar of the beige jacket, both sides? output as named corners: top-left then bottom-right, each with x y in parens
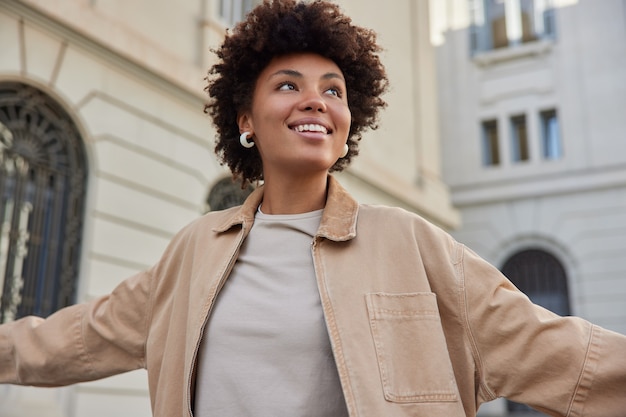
top-left (214, 175), bottom-right (359, 242)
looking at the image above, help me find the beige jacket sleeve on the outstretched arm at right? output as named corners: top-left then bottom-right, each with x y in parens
top-left (460, 244), bottom-right (626, 417)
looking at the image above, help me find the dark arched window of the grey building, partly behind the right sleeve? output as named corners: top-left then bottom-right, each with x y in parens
top-left (501, 249), bottom-right (570, 416)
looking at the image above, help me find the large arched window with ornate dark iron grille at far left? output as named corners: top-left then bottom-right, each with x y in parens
top-left (0, 82), bottom-right (87, 323)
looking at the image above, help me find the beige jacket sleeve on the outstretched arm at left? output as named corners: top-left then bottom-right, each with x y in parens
top-left (0, 271), bottom-right (152, 386)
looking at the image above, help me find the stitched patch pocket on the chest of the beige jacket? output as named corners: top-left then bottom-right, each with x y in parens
top-left (366, 293), bottom-right (458, 403)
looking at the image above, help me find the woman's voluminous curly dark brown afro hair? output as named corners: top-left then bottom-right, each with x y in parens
top-left (204, 0), bottom-right (388, 184)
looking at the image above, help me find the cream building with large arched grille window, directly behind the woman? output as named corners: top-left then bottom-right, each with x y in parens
top-left (0, 0), bottom-right (459, 417)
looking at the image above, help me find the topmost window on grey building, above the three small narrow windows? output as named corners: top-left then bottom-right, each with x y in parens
top-left (469, 0), bottom-right (555, 53)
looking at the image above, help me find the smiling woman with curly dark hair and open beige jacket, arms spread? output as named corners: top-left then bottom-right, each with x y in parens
top-left (0, 0), bottom-right (626, 417)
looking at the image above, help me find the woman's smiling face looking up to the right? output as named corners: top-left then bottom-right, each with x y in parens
top-left (238, 53), bottom-right (351, 182)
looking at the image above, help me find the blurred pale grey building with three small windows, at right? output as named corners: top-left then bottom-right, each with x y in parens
top-left (431, 0), bottom-right (626, 415)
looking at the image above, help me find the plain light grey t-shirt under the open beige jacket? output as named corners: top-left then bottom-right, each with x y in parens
top-left (194, 210), bottom-right (348, 417)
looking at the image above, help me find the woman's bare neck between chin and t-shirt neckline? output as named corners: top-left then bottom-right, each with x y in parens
top-left (262, 175), bottom-right (327, 214)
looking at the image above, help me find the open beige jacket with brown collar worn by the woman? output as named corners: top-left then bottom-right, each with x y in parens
top-left (0, 177), bottom-right (626, 417)
